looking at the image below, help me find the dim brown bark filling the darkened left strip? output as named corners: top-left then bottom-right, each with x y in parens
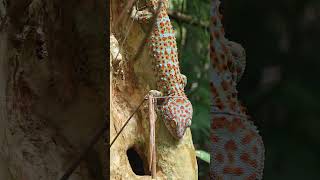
top-left (0, 0), bottom-right (108, 180)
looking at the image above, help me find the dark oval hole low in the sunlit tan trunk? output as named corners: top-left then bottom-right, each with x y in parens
top-left (127, 147), bottom-right (150, 176)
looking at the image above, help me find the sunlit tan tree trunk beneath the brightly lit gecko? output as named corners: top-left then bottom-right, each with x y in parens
top-left (110, 0), bottom-right (198, 180)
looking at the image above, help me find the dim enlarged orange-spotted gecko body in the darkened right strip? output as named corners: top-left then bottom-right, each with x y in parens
top-left (210, 0), bottom-right (264, 180)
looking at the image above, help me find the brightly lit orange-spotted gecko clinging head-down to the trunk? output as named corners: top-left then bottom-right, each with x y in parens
top-left (135, 0), bottom-right (193, 139)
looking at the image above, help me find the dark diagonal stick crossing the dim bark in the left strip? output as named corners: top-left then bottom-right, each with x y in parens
top-left (60, 124), bottom-right (107, 180)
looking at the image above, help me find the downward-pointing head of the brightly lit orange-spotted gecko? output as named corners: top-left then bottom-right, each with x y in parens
top-left (162, 97), bottom-right (193, 139)
